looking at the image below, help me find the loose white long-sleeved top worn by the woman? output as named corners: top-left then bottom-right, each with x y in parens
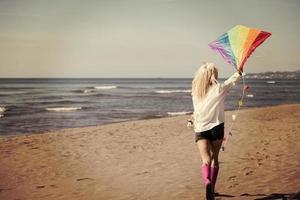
top-left (193, 72), bottom-right (241, 132)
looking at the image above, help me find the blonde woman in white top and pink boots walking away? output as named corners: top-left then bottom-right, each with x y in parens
top-left (192, 63), bottom-right (241, 200)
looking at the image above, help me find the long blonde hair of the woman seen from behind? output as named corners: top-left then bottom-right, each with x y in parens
top-left (192, 63), bottom-right (218, 99)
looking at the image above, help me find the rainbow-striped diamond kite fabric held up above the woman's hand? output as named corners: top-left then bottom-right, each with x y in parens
top-left (209, 25), bottom-right (271, 71)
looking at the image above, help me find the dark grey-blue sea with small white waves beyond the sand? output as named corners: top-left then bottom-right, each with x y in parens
top-left (0, 78), bottom-right (300, 136)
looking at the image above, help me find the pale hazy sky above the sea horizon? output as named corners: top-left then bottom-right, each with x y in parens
top-left (0, 0), bottom-right (300, 78)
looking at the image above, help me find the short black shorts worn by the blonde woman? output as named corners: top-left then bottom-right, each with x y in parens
top-left (195, 123), bottom-right (224, 143)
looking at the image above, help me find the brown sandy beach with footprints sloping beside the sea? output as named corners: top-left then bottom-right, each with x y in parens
top-left (0, 104), bottom-right (300, 200)
